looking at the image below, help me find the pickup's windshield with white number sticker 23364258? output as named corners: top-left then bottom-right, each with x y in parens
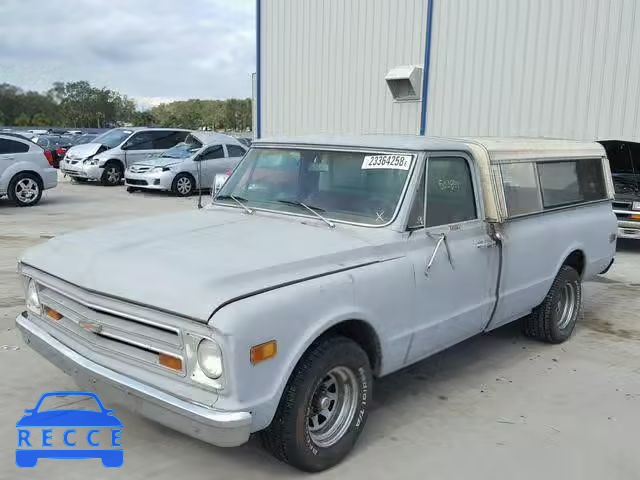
top-left (215, 148), bottom-right (415, 225)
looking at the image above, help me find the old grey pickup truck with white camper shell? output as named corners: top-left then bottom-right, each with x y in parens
top-left (17, 136), bottom-right (617, 471)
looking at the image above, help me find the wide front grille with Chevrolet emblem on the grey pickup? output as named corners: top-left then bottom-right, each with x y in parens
top-left (39, 283), bottom-right (185, 375)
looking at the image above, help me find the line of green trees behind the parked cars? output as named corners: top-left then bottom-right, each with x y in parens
top-left (0, 81), bottom-right (251, 131)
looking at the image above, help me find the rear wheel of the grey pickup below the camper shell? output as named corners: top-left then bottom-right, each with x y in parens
top-left (523, 265), bottom-right (582, 343)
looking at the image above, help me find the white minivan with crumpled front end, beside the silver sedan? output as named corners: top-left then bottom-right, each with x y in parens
top-left (60, 127), bottom-right (189, 186)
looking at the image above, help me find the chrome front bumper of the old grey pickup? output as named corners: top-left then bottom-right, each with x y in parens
top-left (16, 312), bottom-right (251, 447)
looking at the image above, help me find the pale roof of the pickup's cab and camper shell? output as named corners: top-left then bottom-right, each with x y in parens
top-left (253, 135), bottom-right (605, 163)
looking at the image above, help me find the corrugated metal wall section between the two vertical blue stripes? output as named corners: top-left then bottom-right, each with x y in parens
top-left (257, 0), bottom-right (427, 137)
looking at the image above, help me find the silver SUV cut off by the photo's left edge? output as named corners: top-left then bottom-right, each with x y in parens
top-left (0, 133), bottom-right (58, 207)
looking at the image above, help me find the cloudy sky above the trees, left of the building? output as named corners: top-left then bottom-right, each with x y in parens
top-left (0, 0), bottom-right (256, 108)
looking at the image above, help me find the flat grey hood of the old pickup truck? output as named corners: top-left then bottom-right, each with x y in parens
top-left (20, 207), bottom-right (384, 322)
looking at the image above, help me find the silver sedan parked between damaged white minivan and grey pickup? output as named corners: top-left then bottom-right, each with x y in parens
top-left (124, 131), bottom-right (247, 197)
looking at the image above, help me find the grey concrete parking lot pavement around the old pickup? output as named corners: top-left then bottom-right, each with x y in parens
top-left (0, 178), bottom-right (640, 480)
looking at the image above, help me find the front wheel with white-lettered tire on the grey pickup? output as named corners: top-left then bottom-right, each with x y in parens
top-left (261, 336), bottom-right (372, 472)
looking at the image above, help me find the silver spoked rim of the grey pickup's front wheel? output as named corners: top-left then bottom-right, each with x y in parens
top-left (306, 367), bottom-right (359, 448)
